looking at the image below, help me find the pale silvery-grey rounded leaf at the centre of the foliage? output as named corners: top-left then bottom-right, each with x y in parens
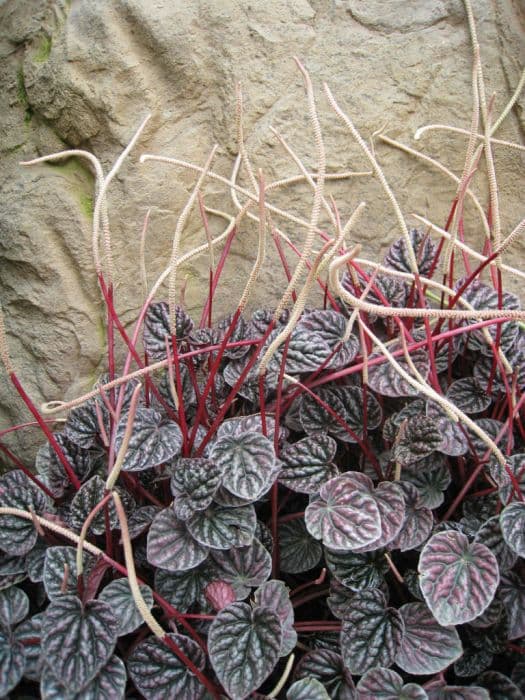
top-left (211, 433), bottom-right (276, 498)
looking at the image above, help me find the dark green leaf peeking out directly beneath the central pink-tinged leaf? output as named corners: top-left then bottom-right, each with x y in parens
top-left (324, 548), bottom-right (388, 591)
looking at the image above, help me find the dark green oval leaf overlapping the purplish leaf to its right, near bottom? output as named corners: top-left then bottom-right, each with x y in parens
top-left (341, 589), bottom-right (405, 675)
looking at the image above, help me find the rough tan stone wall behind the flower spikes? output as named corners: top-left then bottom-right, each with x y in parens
top-left (0, 0), bottom-right (525, 464)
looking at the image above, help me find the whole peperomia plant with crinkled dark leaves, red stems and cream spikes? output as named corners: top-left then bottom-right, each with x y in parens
top-left (0, 3), bottom-right (525, 700)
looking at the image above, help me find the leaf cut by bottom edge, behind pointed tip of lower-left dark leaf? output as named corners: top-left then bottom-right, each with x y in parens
top-left (40, 655), bottom-right (127, 700)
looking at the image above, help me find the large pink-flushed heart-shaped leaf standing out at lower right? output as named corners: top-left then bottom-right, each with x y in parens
top-left (418, 531), bottom-right (499, 625)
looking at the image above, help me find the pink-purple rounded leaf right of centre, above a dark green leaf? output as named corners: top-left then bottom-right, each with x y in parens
top-left (304, 474), bottom-right (381, 551)
